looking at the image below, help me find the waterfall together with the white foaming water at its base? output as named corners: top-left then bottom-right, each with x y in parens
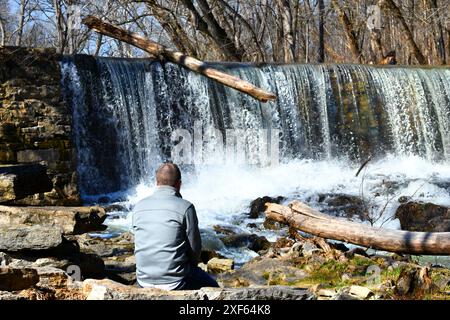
top-left (61, 56), bottom-right (450, 260)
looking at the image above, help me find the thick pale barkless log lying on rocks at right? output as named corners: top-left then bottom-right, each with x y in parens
top-left (266, 201), bottom-right (450, 255)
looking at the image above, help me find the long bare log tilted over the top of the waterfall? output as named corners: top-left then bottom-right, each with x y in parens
top-left (83, 16), bottom-right (276, 102)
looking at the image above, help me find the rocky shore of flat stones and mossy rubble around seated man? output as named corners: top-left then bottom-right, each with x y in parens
top-left (0, 192), bottom-right (450, 300)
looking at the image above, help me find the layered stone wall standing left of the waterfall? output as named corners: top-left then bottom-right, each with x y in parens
top-left (0, 47), bottom-right (80, 205)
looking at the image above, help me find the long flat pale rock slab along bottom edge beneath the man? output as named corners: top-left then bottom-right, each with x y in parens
top-left (83, 279), bottom-right (314, 300)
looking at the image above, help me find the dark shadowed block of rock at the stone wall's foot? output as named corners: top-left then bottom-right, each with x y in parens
top-left (0, 164), bottom-right (53, 203)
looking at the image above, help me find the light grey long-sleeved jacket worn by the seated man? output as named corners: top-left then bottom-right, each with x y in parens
top-left (132, 186), bottom-right (202, 285)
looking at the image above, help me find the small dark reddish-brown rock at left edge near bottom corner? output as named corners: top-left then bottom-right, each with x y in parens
top-left (0, 267), bottom-right (39, 291)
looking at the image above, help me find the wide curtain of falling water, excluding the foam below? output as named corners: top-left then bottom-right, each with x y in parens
top-left (61, 55), bottom-right (450, 195)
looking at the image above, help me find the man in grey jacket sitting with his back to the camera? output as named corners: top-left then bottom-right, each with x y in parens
top-left (132, 163), bottom-right (219, 290)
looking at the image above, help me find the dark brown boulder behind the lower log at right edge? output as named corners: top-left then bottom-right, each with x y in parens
top-left (395, 202), bottom-right (450, 232)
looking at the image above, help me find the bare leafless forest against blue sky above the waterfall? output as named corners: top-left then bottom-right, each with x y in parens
top-left (0, 0), bottom-right (450, 65)
